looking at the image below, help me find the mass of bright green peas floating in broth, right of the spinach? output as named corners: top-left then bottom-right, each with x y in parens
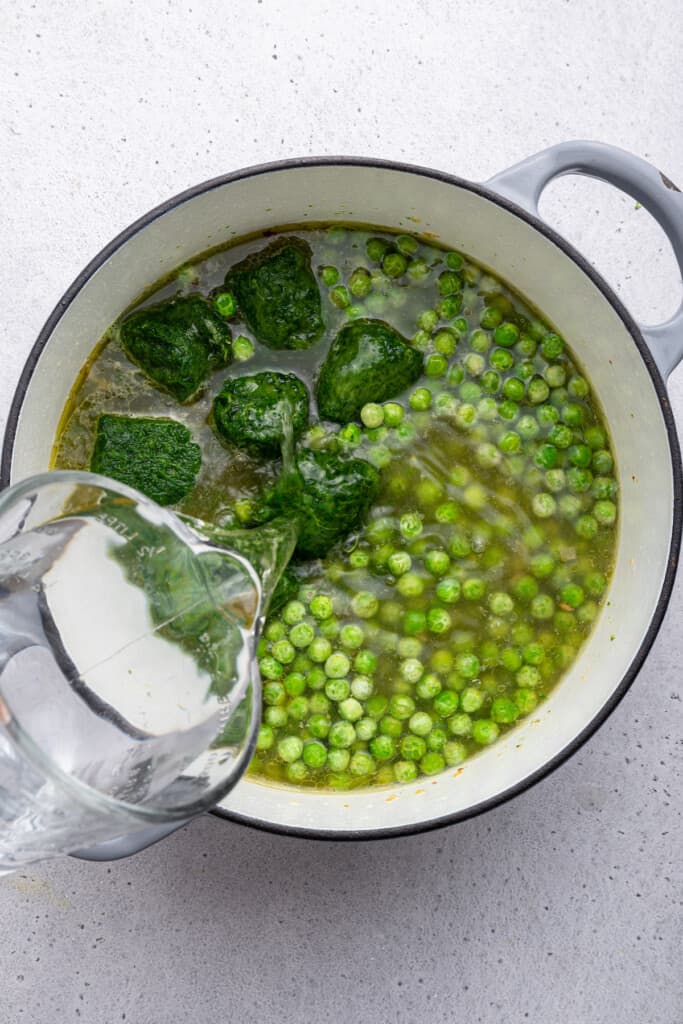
top-left (249, 226), bottom-right (617, 788)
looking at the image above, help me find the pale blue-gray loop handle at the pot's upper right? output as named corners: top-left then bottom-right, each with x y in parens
top-left (485, 141), bottom-right (683, 380)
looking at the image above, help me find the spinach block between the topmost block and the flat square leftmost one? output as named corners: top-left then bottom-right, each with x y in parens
top-left (120, 295), bottom-right (232, 401)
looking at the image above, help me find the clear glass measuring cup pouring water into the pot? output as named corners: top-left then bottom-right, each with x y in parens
top-left (0, 472), bottom-right (295, 873)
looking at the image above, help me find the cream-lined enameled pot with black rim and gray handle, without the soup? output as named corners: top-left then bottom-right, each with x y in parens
top-left (1, 142), bottom-right (683, 839)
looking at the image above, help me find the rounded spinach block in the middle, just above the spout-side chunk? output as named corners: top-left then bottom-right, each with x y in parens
top-left (213, 370), bottom-right (309, 455)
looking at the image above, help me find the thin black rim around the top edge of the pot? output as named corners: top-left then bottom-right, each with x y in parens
top-left (0, 151), bottom-right (683, 841)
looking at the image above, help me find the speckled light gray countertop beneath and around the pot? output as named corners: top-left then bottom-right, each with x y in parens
top-left (0, 0), bottom-right (683, 1024)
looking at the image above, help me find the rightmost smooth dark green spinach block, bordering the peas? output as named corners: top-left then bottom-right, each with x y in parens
top-left (315, 319), bottom-right (423, 423)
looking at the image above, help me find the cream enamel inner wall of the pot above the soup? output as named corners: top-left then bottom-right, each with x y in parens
top-left (7, 165), bottom-right (673, 833)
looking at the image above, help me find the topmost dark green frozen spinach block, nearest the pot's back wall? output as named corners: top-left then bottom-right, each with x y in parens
top-left (225, 238), bottom-right (325, 348)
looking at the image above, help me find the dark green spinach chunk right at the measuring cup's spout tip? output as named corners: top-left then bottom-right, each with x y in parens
top-left (254, 449), bottom-right (379, 558)
